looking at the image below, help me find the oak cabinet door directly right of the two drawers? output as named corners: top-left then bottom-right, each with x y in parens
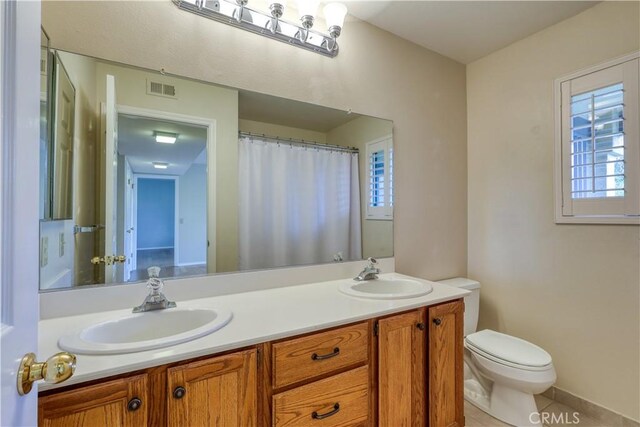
top-left (378, 309), bottom-right (426, 426)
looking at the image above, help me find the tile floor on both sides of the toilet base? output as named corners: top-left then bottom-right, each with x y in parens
top-left (464, 395), bottom-right (608, 427)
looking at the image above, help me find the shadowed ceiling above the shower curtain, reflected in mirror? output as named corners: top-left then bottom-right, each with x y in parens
top-left (238, 90), bottom-right (360, 133)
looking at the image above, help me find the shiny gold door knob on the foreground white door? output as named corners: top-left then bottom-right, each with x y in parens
top-left (18, 351), bottom-right (76, 396)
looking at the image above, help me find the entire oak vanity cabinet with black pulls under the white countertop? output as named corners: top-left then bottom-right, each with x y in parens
top-left (39, 300), bottom-right (464, 427)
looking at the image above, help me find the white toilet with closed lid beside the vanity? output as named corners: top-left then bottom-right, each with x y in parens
top-left (440, 278), bottom-right (556, 426)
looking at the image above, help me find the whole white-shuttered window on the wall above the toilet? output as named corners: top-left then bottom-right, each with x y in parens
top-left (555, 53), bottom-right (640, 224)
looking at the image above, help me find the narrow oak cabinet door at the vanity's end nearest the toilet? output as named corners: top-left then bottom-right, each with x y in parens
top-left (428, 300), bottom-right (464, 427)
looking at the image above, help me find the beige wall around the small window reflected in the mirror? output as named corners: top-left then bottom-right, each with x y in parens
top-left (327, 117), bottom-right (393, 258)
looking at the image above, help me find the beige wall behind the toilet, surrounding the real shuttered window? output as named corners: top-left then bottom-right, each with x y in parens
top-left (467, 2), bottom-right (640, 420)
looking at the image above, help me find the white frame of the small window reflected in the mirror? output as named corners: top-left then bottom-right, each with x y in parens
top-left (365, 135), bottom-right (393, 221)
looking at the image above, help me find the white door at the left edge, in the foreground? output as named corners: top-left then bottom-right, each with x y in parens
top-left (0, 1), bottom-right (41, 426)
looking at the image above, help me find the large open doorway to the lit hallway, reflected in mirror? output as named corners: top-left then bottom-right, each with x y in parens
top-left (116, 107), bottom-right (213, 282)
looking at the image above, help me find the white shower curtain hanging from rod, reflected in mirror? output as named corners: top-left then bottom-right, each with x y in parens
top-left (238, 137), bottom-right (362, 270)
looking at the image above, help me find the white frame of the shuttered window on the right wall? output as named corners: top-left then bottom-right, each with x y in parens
top-left (554, 51), bottom-right (640, 225)
